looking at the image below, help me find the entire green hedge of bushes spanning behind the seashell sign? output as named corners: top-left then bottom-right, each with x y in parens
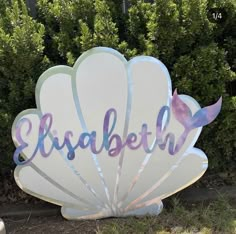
top-left (0, 0), bottom-right (236, 179)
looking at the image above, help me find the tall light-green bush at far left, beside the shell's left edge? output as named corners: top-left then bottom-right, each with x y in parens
top-left (0, 0), bottom-right (49, 169)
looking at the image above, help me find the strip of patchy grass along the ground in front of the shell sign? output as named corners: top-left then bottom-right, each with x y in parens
top-left (4, 197), bottom-right (236, 234)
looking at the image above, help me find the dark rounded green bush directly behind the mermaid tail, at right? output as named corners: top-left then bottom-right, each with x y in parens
top-left (172, 44), bottom-right (236, 171)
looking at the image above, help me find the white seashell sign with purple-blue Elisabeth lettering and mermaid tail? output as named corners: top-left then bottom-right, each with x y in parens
top-left (12, 47), bottom-right (221, 219)
